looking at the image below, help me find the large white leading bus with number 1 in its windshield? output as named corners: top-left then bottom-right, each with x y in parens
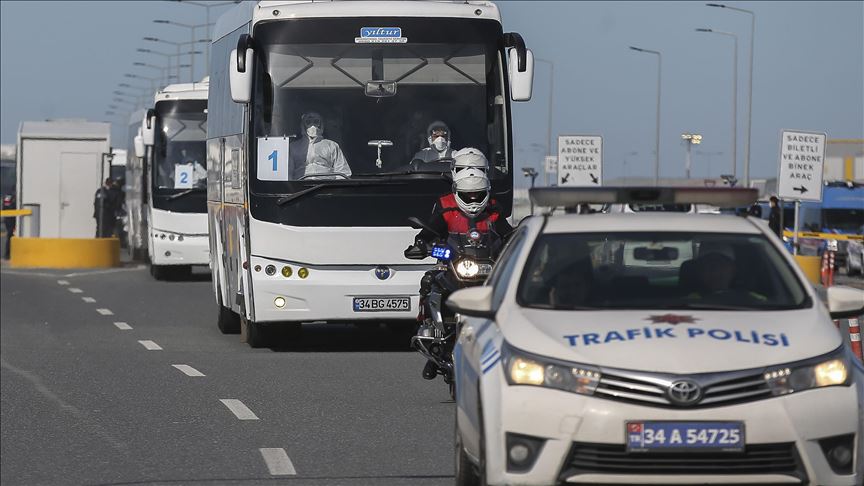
top-left (207, 1), bottom-right (533, 347)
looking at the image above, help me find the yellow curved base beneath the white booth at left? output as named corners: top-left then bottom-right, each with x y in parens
top-left (9, 236), bottom-right (120, 268)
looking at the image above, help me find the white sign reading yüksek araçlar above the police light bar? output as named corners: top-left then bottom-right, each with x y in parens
top-left (558, 135), bottom-right (603, 187)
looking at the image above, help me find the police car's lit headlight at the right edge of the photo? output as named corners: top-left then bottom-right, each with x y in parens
top-left (763, 349), bottom-right (851, 395)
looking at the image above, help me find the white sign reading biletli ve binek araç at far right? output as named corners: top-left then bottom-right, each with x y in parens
top-left (777, 130), bottom-right (828, 201)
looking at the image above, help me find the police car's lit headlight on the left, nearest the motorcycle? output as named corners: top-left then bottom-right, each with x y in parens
top-left (502, 346), bottom-right (600, 395)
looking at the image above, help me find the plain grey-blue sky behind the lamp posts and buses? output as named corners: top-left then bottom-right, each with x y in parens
top-left (0, 1), bottom-right (864, 184)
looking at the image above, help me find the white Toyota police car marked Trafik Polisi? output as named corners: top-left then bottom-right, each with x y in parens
top-left (448, 188), bottom-right (864, 485)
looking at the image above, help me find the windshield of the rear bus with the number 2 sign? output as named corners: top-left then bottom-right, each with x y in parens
top-left (153, 100), bottom-right (207, 190)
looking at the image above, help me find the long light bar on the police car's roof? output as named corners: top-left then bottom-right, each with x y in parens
top-left (529, 187), bottom-right (759, 208)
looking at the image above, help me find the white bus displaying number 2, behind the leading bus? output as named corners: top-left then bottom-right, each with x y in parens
top-left (138, 78), bottom-right (210, 279)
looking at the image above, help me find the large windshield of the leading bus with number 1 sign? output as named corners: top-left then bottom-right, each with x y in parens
top-left (250, 19), bottom-right (512, 193)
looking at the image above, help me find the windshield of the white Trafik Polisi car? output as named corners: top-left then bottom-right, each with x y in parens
top-left (517, 232), bottom-right (810, 310)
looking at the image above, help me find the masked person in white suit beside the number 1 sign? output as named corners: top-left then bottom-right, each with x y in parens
top-left (289, 112), bottom-right (351, 180)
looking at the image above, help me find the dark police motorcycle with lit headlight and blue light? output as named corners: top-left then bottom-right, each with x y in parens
top-left (405, 217), bottom-right (502, 395)
